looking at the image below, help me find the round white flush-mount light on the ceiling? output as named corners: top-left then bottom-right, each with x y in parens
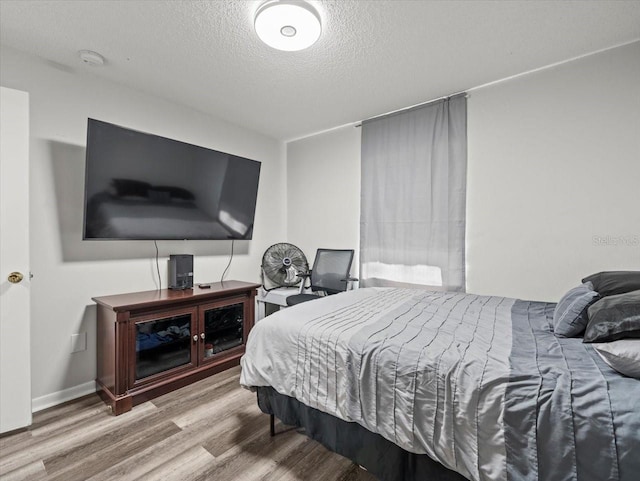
top-left (254, 0), bottom-right (322, 52)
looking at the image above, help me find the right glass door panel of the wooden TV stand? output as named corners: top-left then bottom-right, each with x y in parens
top-left (203, 303), bottom-right (244, 359)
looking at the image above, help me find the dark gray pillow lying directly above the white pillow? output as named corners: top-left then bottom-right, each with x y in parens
top-left (583, 290), bottom-right (640, 342)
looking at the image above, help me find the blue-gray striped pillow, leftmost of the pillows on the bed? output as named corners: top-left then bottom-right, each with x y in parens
top-left (553, 282), bottom-right (600, 337)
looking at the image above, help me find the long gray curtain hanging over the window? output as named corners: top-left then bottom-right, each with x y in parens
top-left (360, 95), bottom-right (467, 291)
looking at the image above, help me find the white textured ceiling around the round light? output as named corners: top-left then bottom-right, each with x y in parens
top-left (0, 0), bottom-right (640, 140)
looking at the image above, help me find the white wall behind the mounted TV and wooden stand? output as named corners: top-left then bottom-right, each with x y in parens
top-left (0, 44), bottom-right (286, 409)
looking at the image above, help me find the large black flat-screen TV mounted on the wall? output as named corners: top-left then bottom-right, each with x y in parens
top-left (83, 119), bottom-right (260, 240)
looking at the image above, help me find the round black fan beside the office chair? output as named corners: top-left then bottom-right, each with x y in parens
top-left (262, 242), bottom-right (309, 291)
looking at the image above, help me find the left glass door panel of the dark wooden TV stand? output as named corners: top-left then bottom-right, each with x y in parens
top-left (135, 313), bottom-right (192, 381)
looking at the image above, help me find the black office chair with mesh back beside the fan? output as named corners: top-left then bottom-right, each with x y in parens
top-left (287, 249), bottom-right (358, 306)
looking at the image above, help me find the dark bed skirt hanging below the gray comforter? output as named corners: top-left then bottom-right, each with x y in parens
top-left (257, 387), bottom-right (467, 481)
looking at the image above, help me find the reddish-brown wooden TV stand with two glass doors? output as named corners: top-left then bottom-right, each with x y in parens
top-left (93, 281), bottom-right (260, 415)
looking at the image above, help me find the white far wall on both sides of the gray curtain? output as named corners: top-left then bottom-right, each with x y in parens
top-left (287, 43), bottom-right (640, 301)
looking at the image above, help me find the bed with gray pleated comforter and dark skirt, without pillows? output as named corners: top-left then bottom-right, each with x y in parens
top-left (240, 288), bottom-right (640, 481)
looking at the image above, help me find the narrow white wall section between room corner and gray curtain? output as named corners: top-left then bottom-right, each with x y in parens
top-left (287, 127), bottom-right (361, 275)
